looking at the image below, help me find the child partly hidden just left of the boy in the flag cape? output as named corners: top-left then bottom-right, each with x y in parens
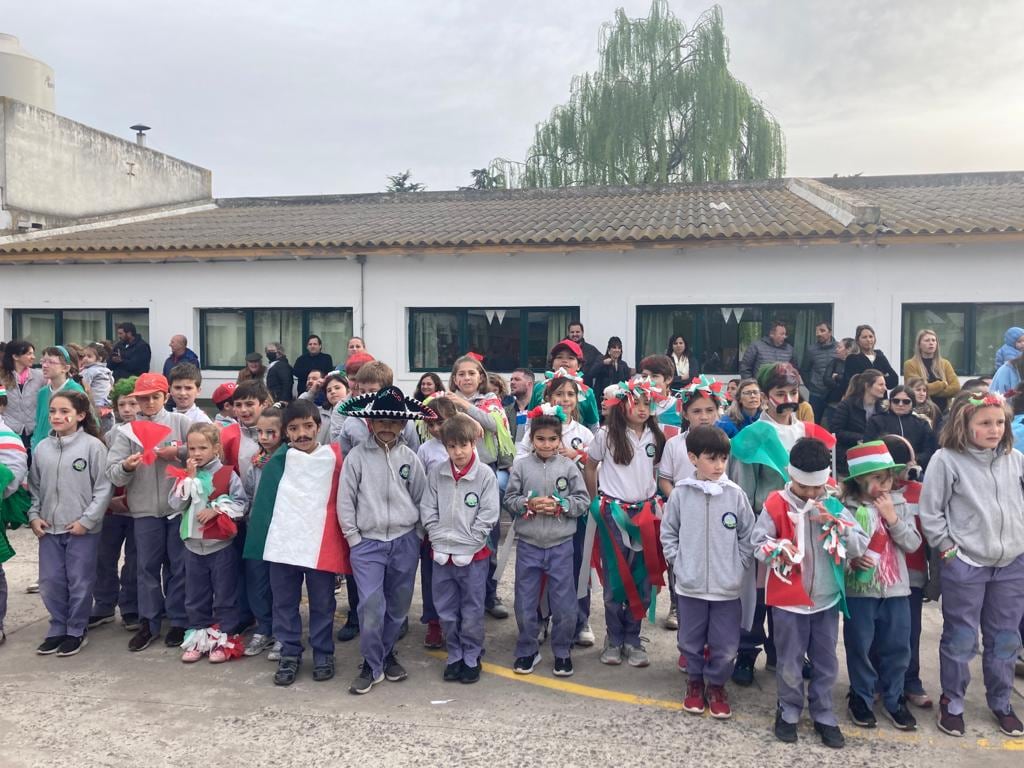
top-left (242, 405), bottom-right (284, 662)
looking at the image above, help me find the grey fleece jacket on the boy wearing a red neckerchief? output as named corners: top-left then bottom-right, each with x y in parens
top-left (420, 459), bottom-right (499, 555)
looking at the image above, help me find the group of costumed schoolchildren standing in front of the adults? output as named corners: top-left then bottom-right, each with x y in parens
top-left (0, 340), bottom-right (1024, 748)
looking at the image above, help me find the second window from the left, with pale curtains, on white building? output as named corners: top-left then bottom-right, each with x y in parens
top-left (200, 307), bottom-right (352, 370)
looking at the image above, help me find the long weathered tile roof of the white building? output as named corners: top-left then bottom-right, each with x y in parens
top-left (0, 172), bottom-right (1024, 261)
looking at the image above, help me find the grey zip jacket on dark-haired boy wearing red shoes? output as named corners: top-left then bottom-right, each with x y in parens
top-left (662, 476), bottom-right (755, 600)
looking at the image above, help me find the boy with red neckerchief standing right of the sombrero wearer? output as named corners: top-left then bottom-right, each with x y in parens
top-left (419, 415), bottom-right (499, 683)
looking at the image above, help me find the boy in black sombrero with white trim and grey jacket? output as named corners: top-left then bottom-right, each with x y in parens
top-left (338, 387), bottom-right (435, 694)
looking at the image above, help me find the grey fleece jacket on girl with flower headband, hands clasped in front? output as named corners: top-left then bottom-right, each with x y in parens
top-left (505, 453), bottom-right (590, 549)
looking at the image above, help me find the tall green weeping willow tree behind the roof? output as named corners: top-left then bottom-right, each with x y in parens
top-left (503, 0), bottom-right (785, 187)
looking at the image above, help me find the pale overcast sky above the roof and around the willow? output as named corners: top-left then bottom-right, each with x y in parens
top-left (8, 0), bottom-right (1024, 197)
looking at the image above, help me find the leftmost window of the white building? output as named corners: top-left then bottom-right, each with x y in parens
top-left (11, 309), bottom-right (150, 353)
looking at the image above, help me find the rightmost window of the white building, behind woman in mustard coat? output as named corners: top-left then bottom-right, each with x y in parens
top-left (894, 303), bottom-right (1024, 376)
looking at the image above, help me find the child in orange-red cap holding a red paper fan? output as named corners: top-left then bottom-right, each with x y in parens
top-left (106, 374), bottom-right (191, 652)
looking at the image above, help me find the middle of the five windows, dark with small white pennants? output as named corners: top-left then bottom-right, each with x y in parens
top-left (409, 307), bottom-right (580, 373)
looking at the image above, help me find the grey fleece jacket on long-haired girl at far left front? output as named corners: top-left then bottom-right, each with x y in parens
top-left (29, 429), bottom-right (114, 534)
